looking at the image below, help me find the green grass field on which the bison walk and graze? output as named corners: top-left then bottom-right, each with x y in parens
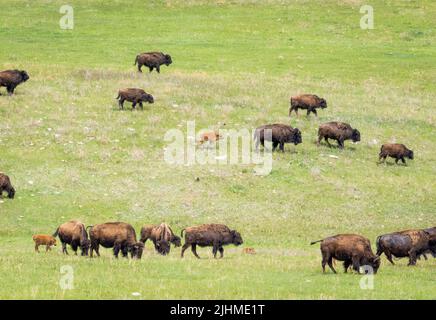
top-left (0, 0), bottom-right (436, 299)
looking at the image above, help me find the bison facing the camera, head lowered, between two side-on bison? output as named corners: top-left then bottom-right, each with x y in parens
top-left (140, 223), bottom-right (181, 255)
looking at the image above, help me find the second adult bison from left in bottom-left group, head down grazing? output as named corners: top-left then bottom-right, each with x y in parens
top-left (86, 222), bottom-right (144, 259)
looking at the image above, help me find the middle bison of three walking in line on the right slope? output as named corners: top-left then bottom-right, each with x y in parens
top-left (318, 121), bottom-right (360, 149)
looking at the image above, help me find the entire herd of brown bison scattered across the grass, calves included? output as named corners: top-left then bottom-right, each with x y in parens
top-left (0, 52), bottom-right (436, 273)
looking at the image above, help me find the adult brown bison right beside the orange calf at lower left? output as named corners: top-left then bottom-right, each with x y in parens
top-left (53, 220), bottom-right (91, 256)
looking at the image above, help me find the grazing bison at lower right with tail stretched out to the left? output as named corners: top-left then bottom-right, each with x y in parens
top-left (310, 234), bottom-right (380, 274)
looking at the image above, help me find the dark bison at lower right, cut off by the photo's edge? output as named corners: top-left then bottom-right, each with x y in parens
top-left (376, 229), bottom-right (436, 266)
